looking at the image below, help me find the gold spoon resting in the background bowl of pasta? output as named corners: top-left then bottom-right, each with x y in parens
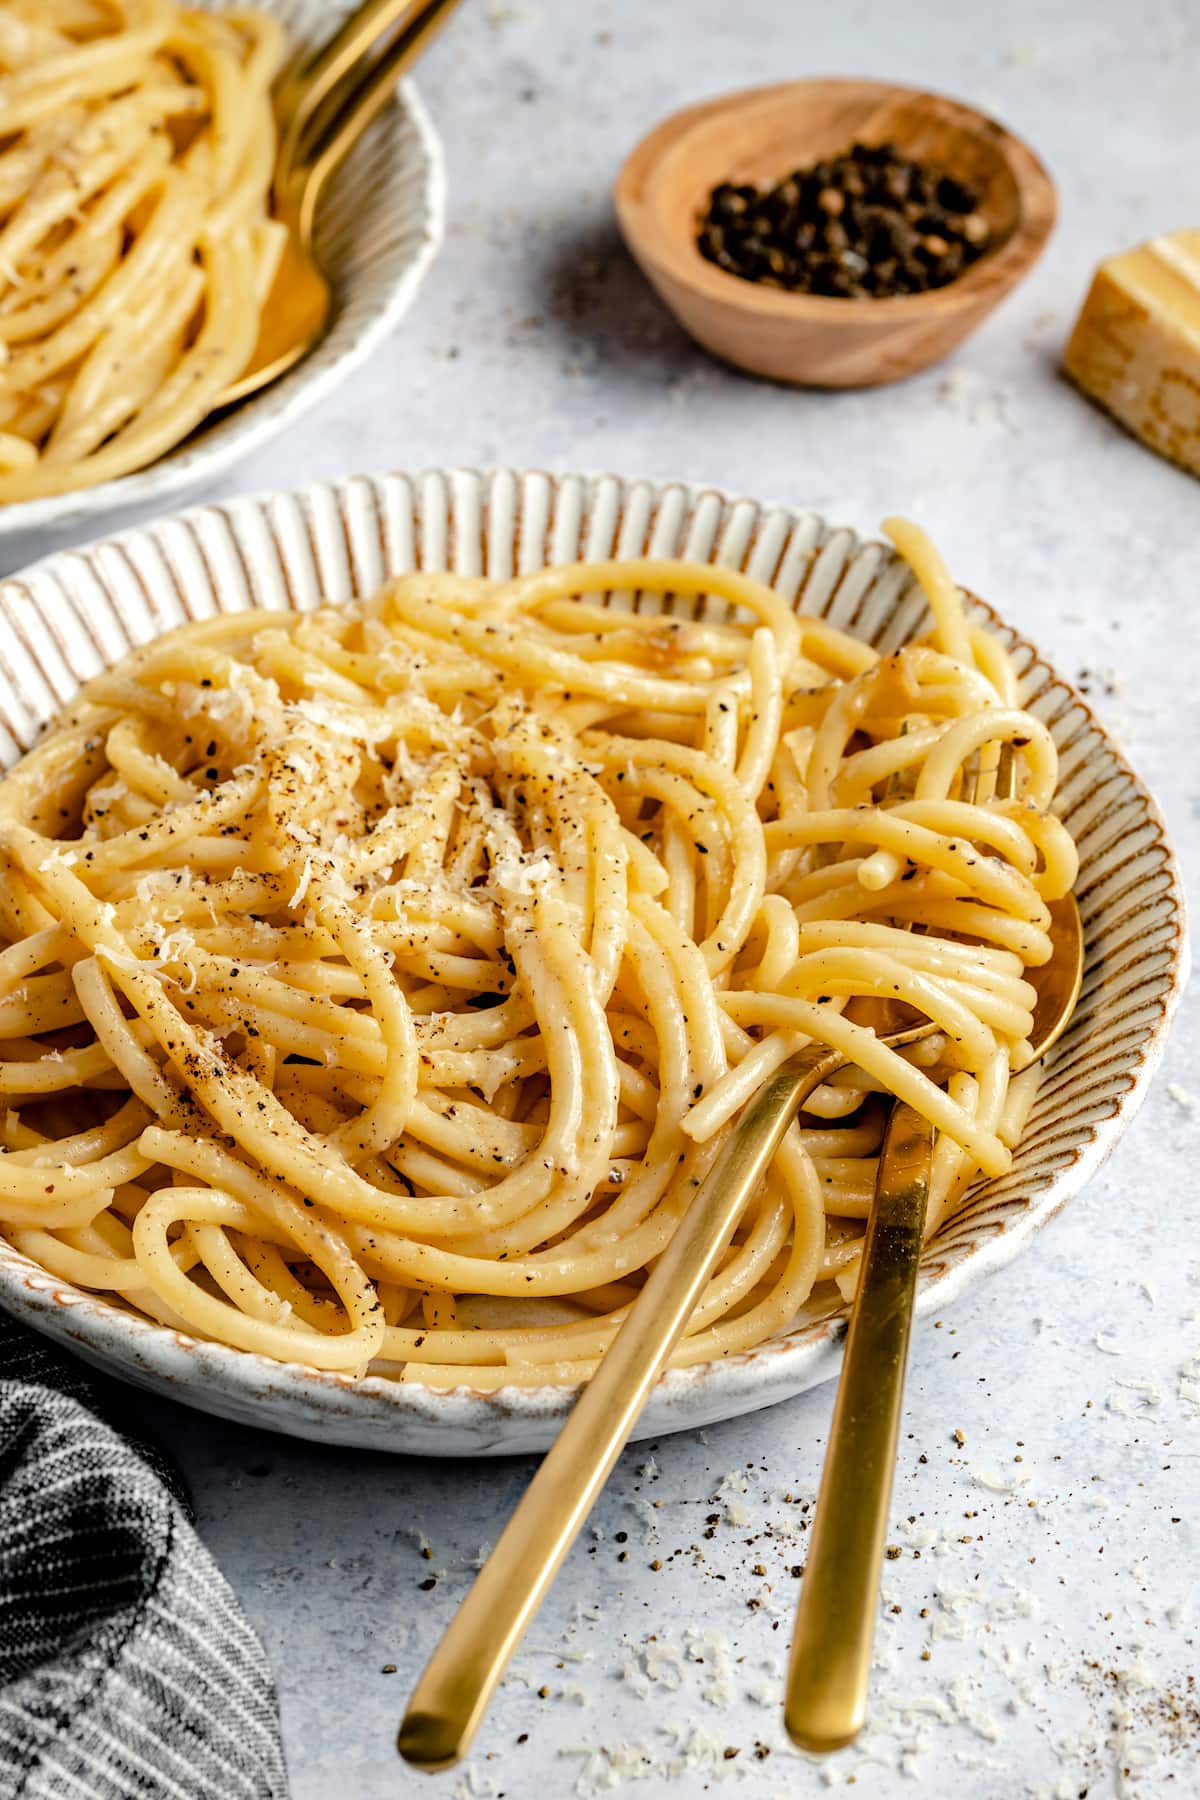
top-left (216, 0), bottom-right (459, 407)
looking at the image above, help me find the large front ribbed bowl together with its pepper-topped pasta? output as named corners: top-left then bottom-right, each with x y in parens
top-left (0, 470), bottom-right (1186, 1454)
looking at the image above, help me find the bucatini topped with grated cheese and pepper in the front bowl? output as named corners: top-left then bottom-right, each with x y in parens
top-left (0, 522), bottom-right (1076, 1388)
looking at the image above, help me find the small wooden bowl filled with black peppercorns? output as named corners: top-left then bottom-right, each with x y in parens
top-left (615, 79), bottom-right (1056, 387)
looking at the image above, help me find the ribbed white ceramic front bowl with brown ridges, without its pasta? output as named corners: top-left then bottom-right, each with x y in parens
top-left (0, 470), bottom-right (1187, 1456)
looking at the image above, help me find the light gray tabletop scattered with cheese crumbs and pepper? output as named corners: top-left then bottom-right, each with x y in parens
top-left (7, 0), bottom-right (1200, 1800)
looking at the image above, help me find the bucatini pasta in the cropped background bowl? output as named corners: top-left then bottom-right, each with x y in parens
top-left (0, 0), bottom-right (284, 502)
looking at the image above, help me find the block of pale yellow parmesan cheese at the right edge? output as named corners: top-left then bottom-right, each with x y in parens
top-left (1063, 230), bottom-right (1200, 475)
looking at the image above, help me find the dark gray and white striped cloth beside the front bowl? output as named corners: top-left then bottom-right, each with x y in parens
top-left (0, 1314), bottom-right (288, 1800)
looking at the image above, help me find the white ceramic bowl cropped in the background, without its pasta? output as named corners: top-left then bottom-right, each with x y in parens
top-left (0, 0), bottom-right (446, 538)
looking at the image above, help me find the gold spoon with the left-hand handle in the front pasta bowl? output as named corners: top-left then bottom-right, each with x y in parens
top-left (398, 902), bottom-right (1083, 1771)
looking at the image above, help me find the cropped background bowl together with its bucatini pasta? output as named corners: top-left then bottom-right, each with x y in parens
top-left (0, 0), bottom-right (444, 533)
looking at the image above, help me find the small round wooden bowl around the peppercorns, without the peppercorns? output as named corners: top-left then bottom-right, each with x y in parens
top-left (615, 77), bottom-right (1056, 387)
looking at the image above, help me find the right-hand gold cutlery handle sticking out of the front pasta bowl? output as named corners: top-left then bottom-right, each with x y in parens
top-left (784, 1103), bottom-right (934, 1753)
